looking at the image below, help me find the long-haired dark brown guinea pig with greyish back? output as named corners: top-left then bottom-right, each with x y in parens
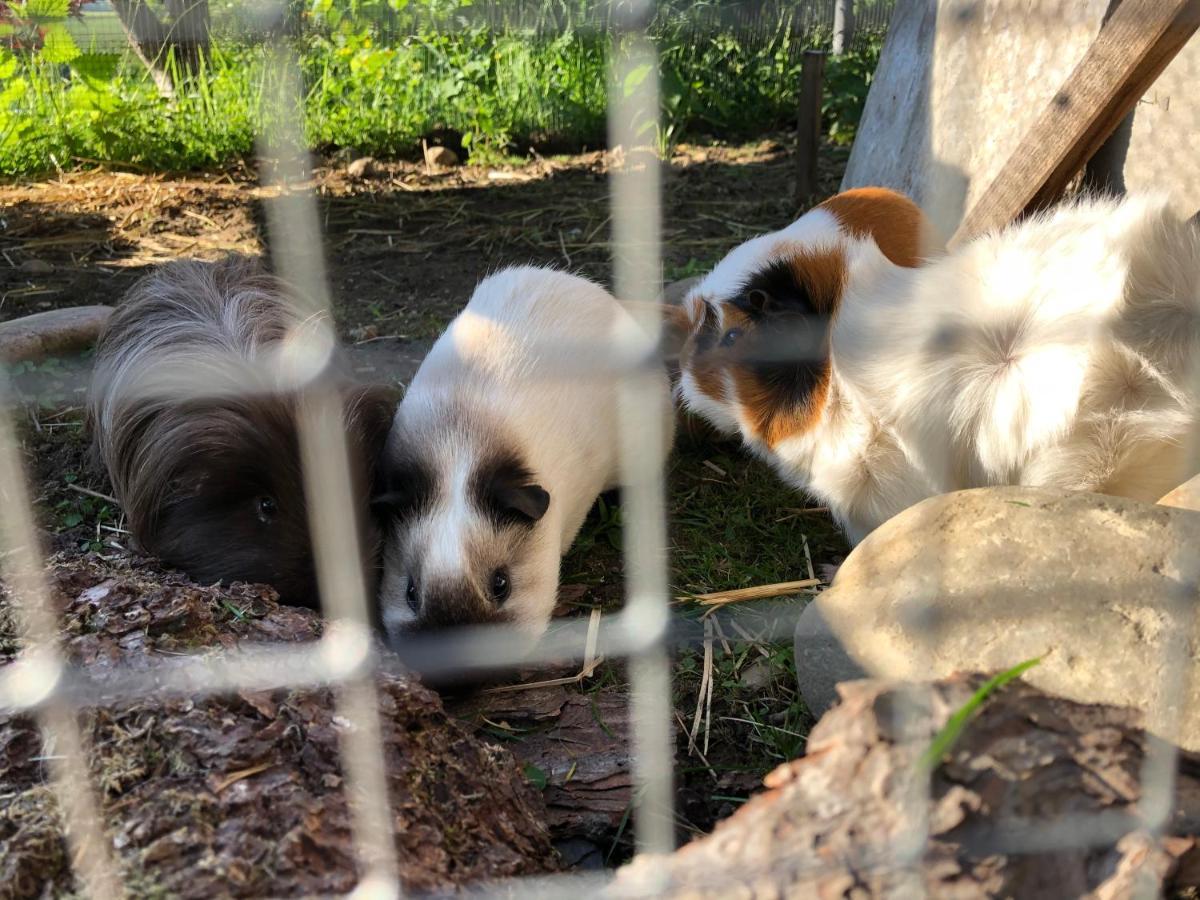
top-left (88, 257), bottom-right (398, 606)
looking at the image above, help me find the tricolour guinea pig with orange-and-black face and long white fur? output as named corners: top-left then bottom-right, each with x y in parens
top-left (673, 188), bottom-right (1200, 544)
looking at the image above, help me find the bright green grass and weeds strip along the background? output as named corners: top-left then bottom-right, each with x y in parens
top-left (0, 16), bottom-right (878, 175)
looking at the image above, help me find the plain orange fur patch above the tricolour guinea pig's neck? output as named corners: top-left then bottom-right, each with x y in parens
top-left (818, 187), bottom-right (937, 269)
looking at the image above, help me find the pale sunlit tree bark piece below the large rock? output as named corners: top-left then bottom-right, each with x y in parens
top-left (606, 674), bottom-right (1200, 900)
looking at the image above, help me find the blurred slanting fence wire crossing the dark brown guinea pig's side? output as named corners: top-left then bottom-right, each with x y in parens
top-left (255, 47), bottom-right (401, 898)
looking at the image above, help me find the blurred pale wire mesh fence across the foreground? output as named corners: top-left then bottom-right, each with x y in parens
top-left (0, 2), bottom-right (1195, 898)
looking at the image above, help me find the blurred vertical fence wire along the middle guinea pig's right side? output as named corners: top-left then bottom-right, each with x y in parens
top-left (608, 0), bottom-right (674, 853)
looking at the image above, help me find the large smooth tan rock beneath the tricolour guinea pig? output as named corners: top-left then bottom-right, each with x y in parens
top-left (796, 487), bottom-right (1200, 749)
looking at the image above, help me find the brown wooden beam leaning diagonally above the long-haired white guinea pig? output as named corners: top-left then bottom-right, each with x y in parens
top-left (950, 0), bottom-right (1200, 246)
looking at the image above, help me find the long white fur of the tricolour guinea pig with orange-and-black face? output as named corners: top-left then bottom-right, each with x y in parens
top-left (682, 197), bottom-right (1200, 542)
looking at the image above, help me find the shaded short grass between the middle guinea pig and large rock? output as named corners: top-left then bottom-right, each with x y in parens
top-left (563, 419), bottom-right (846, 781)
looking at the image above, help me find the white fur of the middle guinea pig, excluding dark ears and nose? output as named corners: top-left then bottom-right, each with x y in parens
top-left (379, 266), bottom-right (672, 636)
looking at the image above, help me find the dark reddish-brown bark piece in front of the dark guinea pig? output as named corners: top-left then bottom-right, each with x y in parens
top-left (0, 558), bottom-right (557, 899)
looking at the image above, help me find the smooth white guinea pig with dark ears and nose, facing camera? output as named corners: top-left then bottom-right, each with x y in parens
top-left (374, 266), bottom-right (673, 638)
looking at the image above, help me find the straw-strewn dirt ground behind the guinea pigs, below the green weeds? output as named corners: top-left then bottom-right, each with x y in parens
top-left (0, 137), bottom-right (845, 340)
